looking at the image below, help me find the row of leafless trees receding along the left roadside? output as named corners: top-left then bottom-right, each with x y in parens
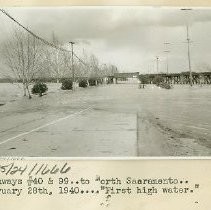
top-left (1, 30), bottom-right (117, 98)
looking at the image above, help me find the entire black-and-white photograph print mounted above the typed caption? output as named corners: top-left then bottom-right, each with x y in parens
top-left (0, 6), bottom-right (211, 157)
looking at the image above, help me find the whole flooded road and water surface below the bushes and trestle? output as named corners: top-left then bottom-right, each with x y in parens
top-left (0, 84), bottom-right (211, 157)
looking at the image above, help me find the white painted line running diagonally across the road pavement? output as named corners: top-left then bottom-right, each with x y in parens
top-left (0, 106), bottom-right (92, 145)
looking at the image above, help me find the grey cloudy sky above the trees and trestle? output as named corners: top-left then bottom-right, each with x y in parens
top-left (0, 7), bottom-right (211, 73)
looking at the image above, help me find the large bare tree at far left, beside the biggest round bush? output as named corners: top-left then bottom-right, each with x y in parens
top-left (3, 30), bottom-right (42, 98)
